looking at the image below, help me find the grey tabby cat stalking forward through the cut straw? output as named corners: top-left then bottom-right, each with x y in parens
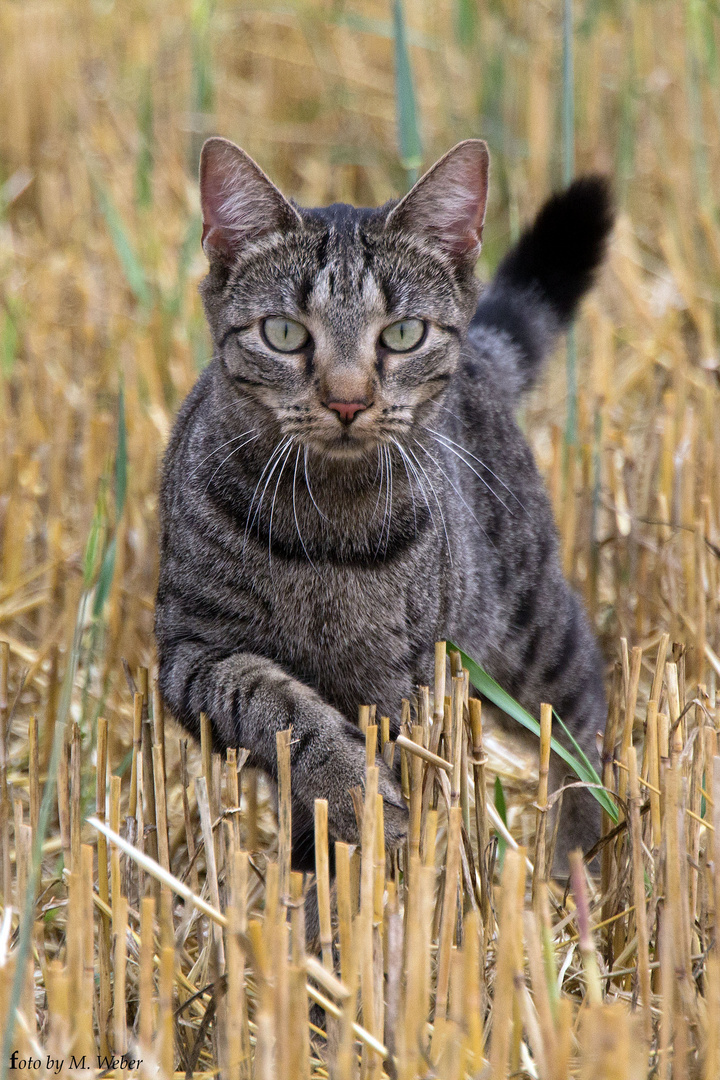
top-left (155, 138), bottom-right (612, 869)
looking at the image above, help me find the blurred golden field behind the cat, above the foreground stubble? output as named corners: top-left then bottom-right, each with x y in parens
top-left (0, 0), bottom-right (720, 760)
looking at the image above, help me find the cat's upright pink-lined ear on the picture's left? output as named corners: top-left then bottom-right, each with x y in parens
top-left (200, 137), bottom-right (301, 262)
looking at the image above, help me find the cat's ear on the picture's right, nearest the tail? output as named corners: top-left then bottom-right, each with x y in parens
top-left (385, 138), bottom-right (490, 261)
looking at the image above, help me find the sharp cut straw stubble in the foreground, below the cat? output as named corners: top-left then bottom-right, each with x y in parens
top-left (2, 630), bottom-right (720, 1080)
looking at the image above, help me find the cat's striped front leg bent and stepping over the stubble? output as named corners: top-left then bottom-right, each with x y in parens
top-left (160, 640), bottom-right (408, 848)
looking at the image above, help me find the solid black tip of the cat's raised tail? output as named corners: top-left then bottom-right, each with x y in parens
top-left (499, 175), bottom-right (615, 324)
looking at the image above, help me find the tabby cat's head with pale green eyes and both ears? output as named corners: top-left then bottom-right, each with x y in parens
top-left (200, 138), bottom-right (488, 457)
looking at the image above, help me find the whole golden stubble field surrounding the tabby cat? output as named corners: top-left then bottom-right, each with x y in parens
top-left (0, 0), bottom-right (720, 1080)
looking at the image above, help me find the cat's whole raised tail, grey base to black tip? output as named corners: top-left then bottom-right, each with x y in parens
top-left (470, 176), bottom-right (614, 391)
